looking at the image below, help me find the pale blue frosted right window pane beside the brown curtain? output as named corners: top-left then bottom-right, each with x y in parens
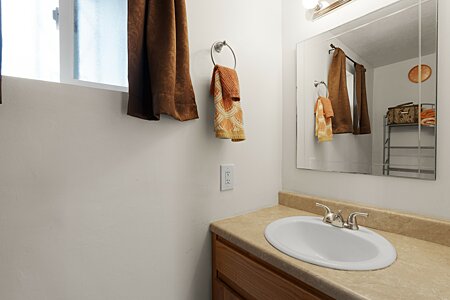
top-left (74, 0), bottom-right (128, 86)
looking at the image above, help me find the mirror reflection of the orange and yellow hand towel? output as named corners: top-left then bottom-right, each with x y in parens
top-left (314, 97), bottom-right (334, 143)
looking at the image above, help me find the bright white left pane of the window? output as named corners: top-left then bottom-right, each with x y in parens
top-left (2, 0), bottom-right (59, 81)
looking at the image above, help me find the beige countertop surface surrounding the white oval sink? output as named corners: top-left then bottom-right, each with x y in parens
top-left (211, 205), bottom-right (450, 300)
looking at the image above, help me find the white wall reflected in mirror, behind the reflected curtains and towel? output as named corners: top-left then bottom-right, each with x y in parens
top-left (297, 32), bottom-right (373, 174)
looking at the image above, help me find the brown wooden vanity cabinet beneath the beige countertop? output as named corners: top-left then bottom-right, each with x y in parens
top-left (212, 234), bottom-right (333, 300)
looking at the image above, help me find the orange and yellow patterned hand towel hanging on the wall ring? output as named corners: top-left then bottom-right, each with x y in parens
top-left (210, 65), bottom-right (245, 142)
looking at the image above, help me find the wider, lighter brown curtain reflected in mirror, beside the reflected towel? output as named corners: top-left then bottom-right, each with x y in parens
top-left (328, 48), bottom-right (353, 134)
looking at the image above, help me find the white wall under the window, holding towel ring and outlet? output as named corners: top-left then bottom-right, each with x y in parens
top-left (0, 0), bottom-right (282, 300)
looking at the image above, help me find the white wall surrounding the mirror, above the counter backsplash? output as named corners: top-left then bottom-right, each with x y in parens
top-left (282, 0), bottom-right (450, 219)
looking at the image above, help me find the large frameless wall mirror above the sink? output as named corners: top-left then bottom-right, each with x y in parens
top-left (297, 0), bottom-right (438, 180)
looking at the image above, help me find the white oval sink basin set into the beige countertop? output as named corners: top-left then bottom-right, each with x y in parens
top-left (265, 216), bottom-right (397, 271)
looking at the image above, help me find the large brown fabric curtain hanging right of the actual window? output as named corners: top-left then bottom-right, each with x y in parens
top-left (128, 0), bottom-right (198, 121)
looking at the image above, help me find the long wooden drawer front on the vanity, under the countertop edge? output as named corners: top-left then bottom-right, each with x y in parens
top-left (215, 241), bottom-right (330, 300)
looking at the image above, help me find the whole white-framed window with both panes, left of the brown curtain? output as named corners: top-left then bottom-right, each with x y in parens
top-left (2, 0), bottom-right (128, 91)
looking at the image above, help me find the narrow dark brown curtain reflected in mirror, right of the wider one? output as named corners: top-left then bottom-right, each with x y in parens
top-left (353, 63), bottom-right (371, 134)
